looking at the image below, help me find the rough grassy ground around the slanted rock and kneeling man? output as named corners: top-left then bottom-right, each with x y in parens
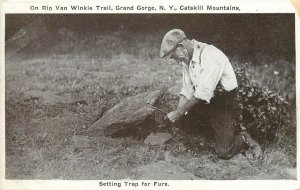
top-left (5, 28), bottom-right (296, 179)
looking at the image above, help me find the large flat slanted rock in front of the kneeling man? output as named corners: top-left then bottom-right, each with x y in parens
top-left (89, 89), bottom-right (166, 138)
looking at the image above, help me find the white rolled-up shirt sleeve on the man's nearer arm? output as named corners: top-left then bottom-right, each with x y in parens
top-left (194, 55), bottom-right (225, 103)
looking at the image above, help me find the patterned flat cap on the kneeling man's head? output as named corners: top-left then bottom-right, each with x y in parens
top-left (160, 29), bottom-right (186, 61)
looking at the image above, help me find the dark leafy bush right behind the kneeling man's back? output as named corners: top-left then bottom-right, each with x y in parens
top-left (235, 67), bottom-right (292, 141)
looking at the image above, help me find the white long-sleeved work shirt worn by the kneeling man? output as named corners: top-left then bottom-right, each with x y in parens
top-left (180, 40), bottom-right (238, 103)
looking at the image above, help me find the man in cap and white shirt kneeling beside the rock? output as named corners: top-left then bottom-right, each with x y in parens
top-left (160, 29), bottom-right (262, 159)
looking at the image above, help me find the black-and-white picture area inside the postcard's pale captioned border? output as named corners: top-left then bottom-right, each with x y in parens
top-left (5, 13), bottom-right (297, 182)
